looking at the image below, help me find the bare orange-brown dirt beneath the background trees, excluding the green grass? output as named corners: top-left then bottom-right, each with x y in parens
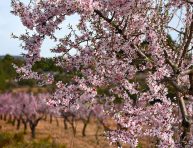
top-left (0, 118), bottom-right (154, 148)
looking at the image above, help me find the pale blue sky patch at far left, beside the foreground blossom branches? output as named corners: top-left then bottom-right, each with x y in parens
top-left (0, 0), bottom-right (25, 55)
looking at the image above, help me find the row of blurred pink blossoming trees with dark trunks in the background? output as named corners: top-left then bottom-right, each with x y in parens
top-left (0, 93), bottom-right (110, 142)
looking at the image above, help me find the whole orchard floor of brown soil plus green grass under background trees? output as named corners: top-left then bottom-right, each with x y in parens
top-left (0, 118), bottom-right (154, 148)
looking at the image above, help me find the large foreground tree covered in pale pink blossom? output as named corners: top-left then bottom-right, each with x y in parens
top-left (12, 0), bottom-right (193, 147)
